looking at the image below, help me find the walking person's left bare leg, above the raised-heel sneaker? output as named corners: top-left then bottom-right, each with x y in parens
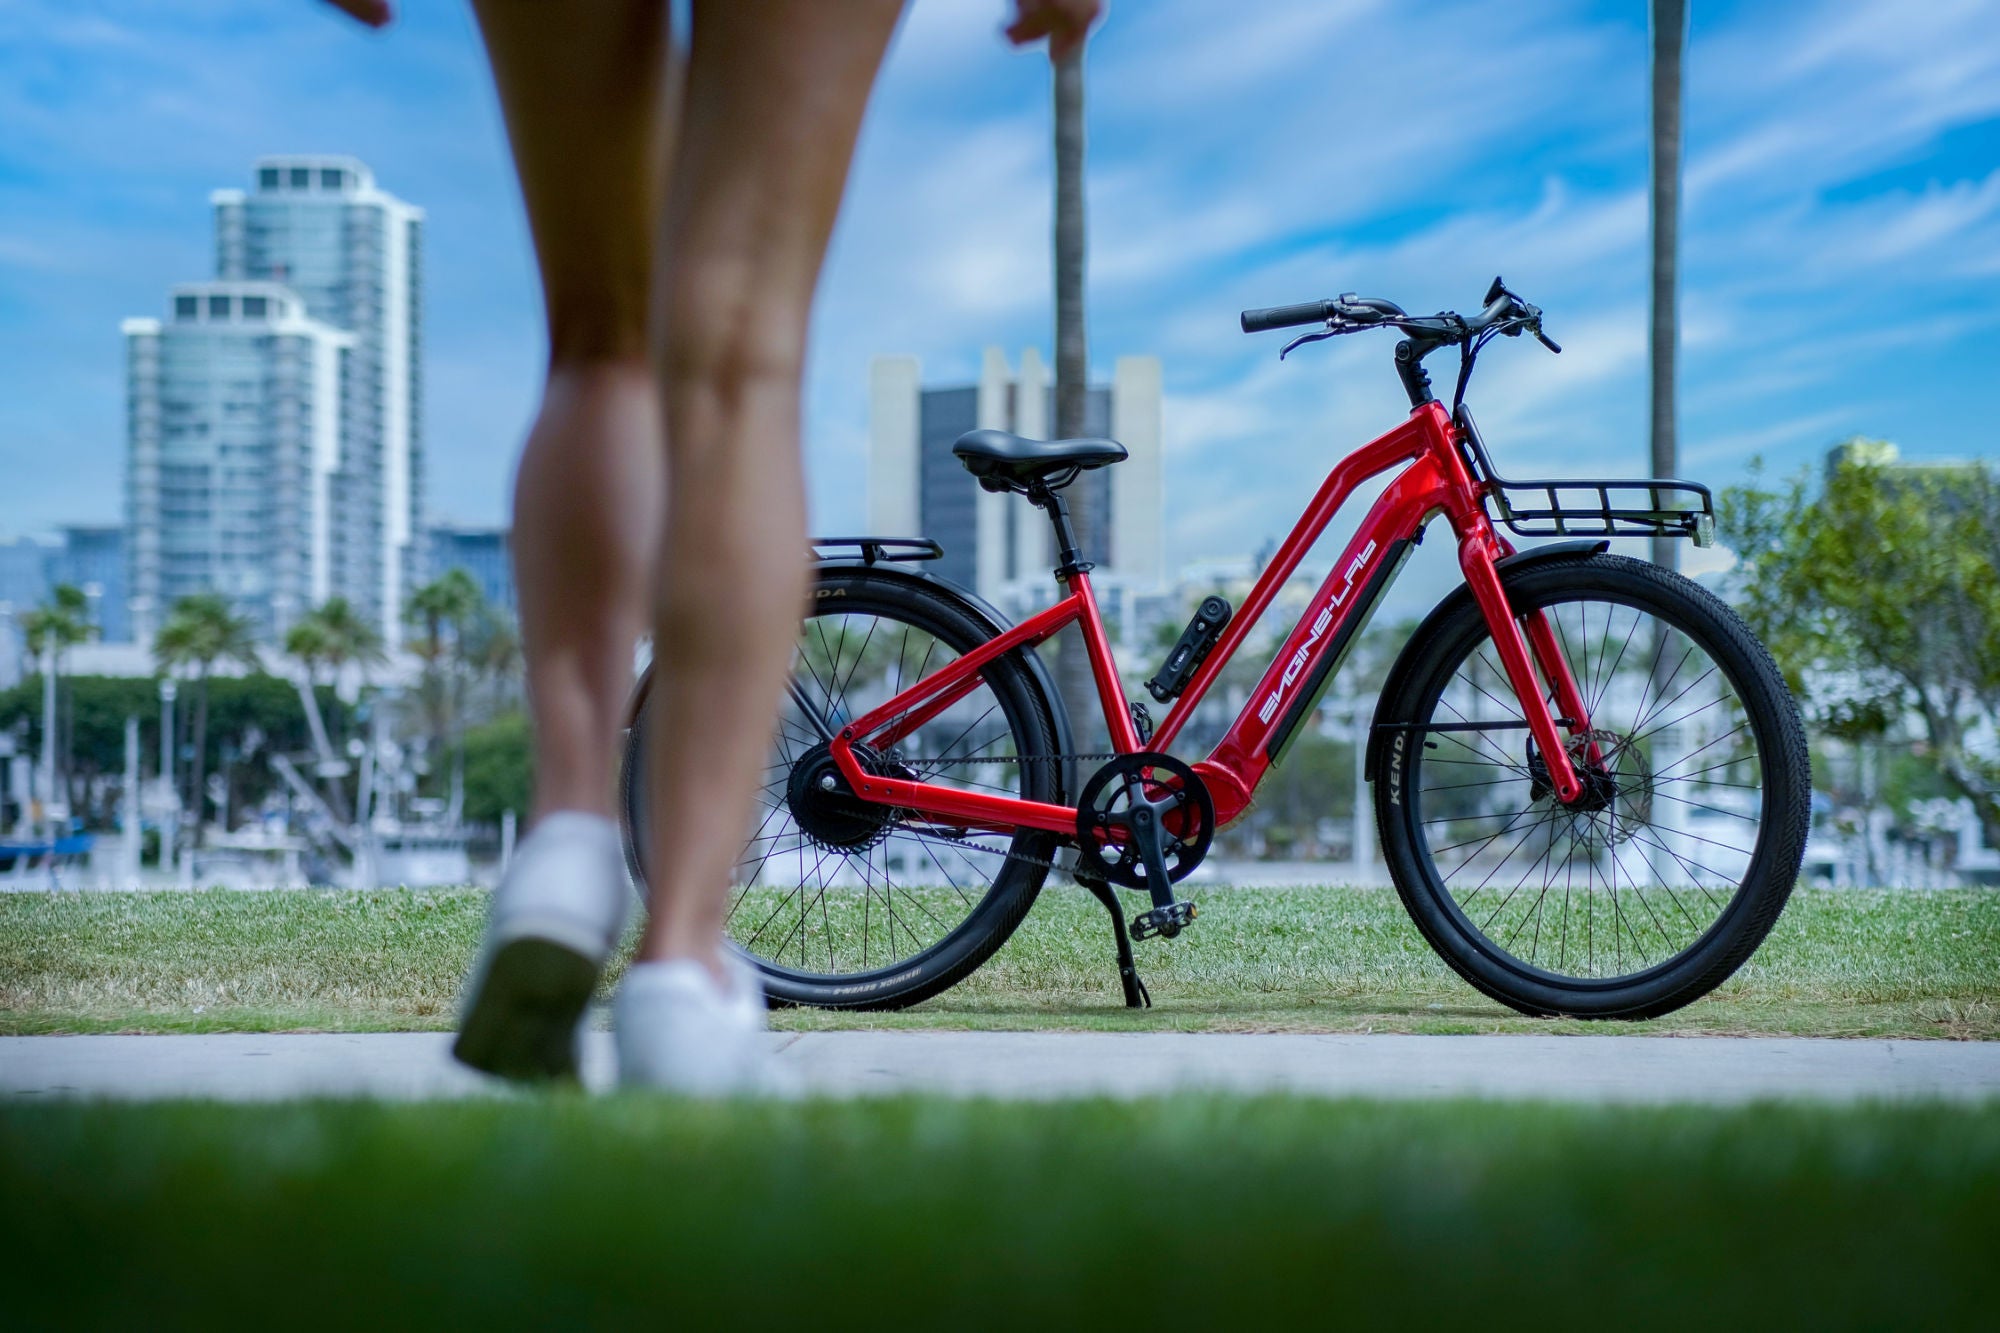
top-left (474, 0), bottom-right (672, 819)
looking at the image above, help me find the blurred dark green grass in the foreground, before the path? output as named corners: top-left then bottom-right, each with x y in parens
top-left (0, 1095), bottom-right (2000, 1331)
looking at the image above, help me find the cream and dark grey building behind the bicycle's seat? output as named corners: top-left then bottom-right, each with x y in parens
top-left (868, 348), bottom-right (1166, 600)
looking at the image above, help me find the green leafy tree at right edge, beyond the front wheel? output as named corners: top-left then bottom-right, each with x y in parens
top-left (1722, 440), bottom-right (2000, 845)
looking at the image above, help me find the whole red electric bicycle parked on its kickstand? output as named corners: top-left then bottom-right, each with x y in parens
top-left (624, 278), bottom-right (1810, 1019)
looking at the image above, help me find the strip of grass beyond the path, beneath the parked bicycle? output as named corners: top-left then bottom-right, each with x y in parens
top-left (0, 887), bottom-right (2000, 1039)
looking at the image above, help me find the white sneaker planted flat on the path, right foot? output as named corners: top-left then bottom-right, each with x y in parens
top-left (614, 955), bottom-right (790, 1097)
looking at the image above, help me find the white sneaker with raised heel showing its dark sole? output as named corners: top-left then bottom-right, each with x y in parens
top-left (452, 811), bottom-right (630, 1079)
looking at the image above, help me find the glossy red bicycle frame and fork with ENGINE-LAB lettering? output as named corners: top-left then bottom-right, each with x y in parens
top-left (828, 400), bottom-right (1590, 835)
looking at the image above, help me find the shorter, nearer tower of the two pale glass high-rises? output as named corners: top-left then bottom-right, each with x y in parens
top-left (124, 282), bottom-right (356, 642)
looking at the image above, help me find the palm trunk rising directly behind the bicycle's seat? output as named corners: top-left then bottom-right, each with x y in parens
top-left (1054, 44), bottom-right (1102, 751)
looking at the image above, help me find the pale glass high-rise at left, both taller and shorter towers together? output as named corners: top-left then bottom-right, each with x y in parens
top-left (126, 156), bottom-right (424, 644)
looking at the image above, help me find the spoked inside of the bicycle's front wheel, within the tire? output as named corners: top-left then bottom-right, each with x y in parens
top-left (1406, 594), bottom-right (1762, 979)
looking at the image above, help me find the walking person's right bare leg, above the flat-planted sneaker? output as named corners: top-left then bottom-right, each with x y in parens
top-left (640, 0), bottom-right (902, 977)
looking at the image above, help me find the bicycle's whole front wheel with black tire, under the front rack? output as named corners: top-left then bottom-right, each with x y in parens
top-left (1376, 554), bottom-right (1812, 1019)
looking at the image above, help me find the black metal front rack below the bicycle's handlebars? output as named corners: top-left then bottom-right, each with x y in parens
top-left (1458, 406), bottom-right (1716, 546)
